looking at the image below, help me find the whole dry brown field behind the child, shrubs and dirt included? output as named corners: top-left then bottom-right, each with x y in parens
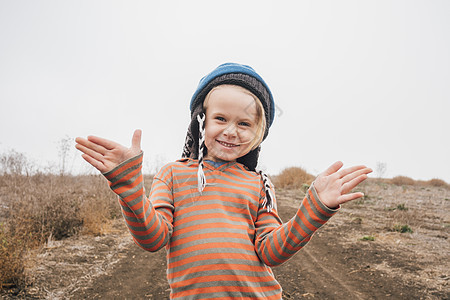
top-left (0, 163), bottom-right (450, 299)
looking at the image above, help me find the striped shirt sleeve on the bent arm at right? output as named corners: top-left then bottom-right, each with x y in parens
top-left (255, 184), bottom-right (339, 266)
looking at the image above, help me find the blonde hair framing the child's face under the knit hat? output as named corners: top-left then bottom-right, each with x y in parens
top-left (203, 84), bottom-right (266, 150)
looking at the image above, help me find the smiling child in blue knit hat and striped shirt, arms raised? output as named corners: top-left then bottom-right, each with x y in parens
top-left (76, 63), bottom-right (372, 299)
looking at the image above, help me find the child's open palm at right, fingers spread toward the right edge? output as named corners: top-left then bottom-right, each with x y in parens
top-left (314, 161), bottom-right (372, 208)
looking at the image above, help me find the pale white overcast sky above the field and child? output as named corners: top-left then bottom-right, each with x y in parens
top-left (0, 0), bottom-right (450, 182)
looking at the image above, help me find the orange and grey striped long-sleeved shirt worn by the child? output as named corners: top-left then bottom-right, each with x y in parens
top-left (104, 153), bottom-right (337, 299)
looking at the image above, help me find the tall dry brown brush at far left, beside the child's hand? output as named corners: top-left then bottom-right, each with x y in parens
top-left (0, 174), bottom-right (120, 286)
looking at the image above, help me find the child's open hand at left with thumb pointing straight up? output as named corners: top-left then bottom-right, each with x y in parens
top-left (75, 129), bottom-right (142, 173)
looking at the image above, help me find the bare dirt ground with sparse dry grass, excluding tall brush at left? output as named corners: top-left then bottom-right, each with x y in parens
top-left (1, 182), bottom-right (450, 299)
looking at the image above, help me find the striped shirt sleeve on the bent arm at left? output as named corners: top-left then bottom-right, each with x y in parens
top-left (103, 152), bottom-right (173, 252)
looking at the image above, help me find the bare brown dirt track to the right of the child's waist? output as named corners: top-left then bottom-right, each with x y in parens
top-left (274, 207), bottom-right (426, 299)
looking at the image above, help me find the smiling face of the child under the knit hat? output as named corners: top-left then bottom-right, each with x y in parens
top-left (205, 85), bottom-right (257, 162)
